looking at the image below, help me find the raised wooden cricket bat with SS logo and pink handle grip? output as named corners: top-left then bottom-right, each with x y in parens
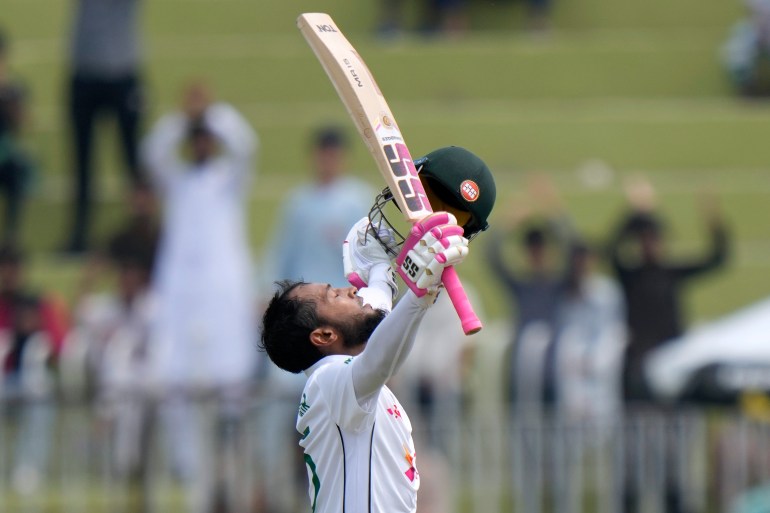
top-left (297, 13), bottom-right (482, 335)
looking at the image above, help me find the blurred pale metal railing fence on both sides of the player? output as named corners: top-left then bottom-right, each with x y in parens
top-left (0, 391), bottom-right (770, 513)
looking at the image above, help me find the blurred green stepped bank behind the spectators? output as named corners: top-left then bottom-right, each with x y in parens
top-left (0, 0), bottom-right (770, 322)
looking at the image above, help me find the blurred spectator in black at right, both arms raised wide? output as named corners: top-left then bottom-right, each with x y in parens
top-left (608, 180), bottom-right (729, 401)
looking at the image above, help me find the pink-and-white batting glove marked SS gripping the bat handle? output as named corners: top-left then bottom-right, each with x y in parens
top-left (396, 212), bottom-right (468, 297)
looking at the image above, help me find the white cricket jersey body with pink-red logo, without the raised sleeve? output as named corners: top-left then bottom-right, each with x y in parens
top-left (297, 355), bottom-right (420, 513)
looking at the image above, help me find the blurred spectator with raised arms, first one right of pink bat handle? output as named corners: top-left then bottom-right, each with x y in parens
top-left (488, 177), bottom-right (574, 403)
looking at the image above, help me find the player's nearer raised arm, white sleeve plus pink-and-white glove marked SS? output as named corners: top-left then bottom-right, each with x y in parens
top-left (352, 212), bottom-right (468, 407)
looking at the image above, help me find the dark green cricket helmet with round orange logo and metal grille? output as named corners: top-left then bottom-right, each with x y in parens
top-left (369, 146), bottom-right (496, 255)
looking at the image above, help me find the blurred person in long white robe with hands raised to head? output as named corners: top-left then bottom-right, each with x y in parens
top-left (144, 83), bottom-right (257, 386)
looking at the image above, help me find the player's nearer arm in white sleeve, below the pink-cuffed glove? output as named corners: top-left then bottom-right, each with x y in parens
top-left (352, 292), bottom-right (432, 404)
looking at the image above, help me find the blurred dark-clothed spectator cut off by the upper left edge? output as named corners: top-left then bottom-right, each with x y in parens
top-left (0, 29), bottom-right (34, 243)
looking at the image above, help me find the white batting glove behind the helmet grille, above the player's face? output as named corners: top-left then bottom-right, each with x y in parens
top-left (342, 217), bottom-right (398, 299)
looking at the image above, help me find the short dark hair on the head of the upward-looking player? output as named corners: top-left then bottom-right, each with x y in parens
top-left (260, 280), bottom-right (323, 374)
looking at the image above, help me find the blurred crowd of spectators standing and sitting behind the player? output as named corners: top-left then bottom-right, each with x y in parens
top-left (0, 0), bottom-right (752, 512)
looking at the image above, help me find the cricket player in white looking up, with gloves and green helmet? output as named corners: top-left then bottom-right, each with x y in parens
top-left (262, 147), bottom-right (495, 513)
